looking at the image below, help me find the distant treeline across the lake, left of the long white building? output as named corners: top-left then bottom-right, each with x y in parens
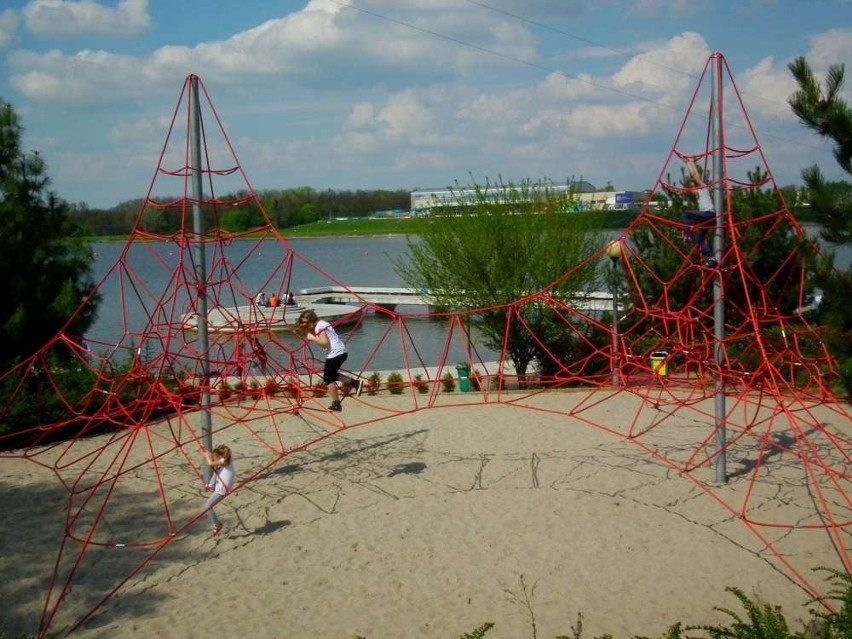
top-left (71, 187), bottom-right (411, 236)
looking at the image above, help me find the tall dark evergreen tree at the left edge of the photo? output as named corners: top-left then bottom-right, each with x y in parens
top-left (0, 101), bottom-right (97, 370)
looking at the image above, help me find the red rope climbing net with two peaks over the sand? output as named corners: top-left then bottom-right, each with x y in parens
top-left (0, 54), bottom-right (852, 636)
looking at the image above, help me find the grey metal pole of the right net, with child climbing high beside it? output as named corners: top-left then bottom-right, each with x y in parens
top-left (710, 53), bottom-right (728, 484)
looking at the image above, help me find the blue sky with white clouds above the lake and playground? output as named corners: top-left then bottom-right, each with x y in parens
top-left (0, 0), bottom-right (852, 207)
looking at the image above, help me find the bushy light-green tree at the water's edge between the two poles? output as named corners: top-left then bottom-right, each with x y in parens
top-left (394, 175), bottom-right (603, 375)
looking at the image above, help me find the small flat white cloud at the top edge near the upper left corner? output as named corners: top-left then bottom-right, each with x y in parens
top-left (23, 0), bottom-right (151, 37)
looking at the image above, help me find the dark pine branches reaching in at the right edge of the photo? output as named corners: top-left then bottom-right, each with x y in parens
top-left (788, 57), bottom-right (852, 395)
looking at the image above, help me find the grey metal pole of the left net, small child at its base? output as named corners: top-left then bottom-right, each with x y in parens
top-left (189, 75), bottom-right (213, 481)
